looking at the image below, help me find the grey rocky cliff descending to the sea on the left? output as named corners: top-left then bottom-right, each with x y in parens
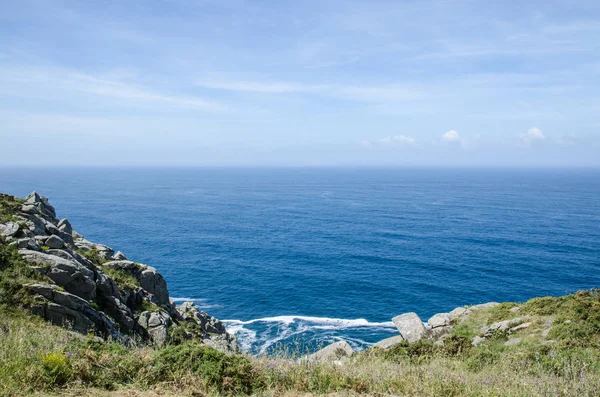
top-left (0, 192), bottom-right (239, 352)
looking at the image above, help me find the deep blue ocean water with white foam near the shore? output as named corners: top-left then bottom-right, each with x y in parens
top-left (0, 168), bottom-right (600, 354)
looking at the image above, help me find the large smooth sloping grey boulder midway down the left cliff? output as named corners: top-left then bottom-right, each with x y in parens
top-left (19, 250), bottom-right (96, 301)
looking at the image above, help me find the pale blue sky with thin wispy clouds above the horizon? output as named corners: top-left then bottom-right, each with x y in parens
top-left (0, 0), bottom-right (600, 167)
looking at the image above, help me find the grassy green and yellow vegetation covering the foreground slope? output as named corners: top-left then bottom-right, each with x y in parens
top-left (0, 286), bottom-right (600, 396)
